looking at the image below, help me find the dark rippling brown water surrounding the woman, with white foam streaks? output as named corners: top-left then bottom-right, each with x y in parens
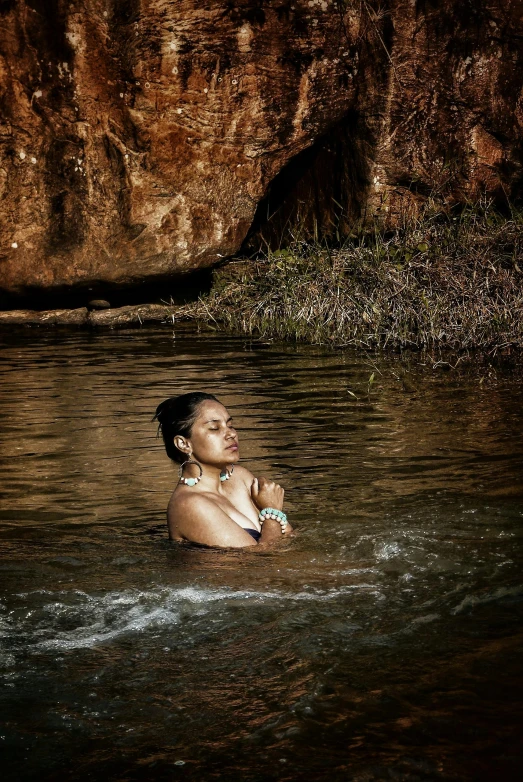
top-left (0, 330), bottom-right (523, 782)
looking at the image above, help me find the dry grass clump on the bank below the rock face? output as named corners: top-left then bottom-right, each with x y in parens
top-left (181, 202), bottom-right (523, 352)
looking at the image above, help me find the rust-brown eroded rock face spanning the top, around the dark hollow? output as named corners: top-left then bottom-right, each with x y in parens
top-left (0, 0), bottom-right (523, 293)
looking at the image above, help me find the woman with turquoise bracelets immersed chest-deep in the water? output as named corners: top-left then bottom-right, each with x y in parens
top-left (154, 393), bottom-right (292, 548)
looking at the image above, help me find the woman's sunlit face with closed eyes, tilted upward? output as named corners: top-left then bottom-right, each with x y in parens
top-left (187, 399), bottom-right (240, 467)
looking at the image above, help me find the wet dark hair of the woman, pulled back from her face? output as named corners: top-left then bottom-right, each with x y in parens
top-left (153, 391), bottom-right (219, 464)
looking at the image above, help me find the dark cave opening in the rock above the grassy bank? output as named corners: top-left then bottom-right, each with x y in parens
top-left (241, 111), bottom-right (372, 254)
